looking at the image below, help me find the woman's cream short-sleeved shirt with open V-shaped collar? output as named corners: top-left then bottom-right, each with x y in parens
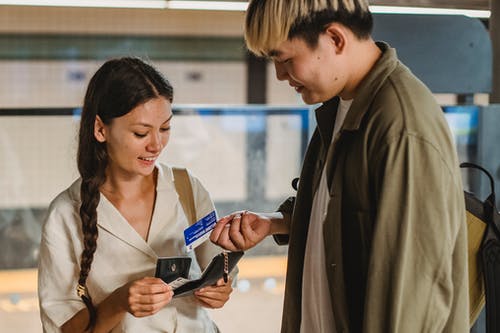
top-left (38, 165), bottom-right (221, 333)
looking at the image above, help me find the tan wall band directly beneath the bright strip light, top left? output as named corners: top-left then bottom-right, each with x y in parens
top-left (0, 6), bottom-right (245, 36)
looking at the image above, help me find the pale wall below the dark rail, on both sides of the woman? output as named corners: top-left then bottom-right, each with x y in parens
top-left (0, 113), bottom-right (302, 208)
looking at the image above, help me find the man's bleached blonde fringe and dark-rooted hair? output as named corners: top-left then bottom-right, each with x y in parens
top-left (245, 0), bottom-right (373, 56)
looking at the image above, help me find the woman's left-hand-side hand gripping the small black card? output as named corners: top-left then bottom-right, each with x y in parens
top-left (117, 277), bottom-right (174, 317)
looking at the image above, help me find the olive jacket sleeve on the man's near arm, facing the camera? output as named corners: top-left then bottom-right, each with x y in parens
top-left (363, 134), bottom-right (469, 333)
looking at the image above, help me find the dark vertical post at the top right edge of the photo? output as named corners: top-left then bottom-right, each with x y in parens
top-left (489, 0), bottom-right (500, 104)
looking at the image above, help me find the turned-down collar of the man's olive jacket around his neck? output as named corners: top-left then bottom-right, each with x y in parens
top-left (316, 42), bottom-right (399, 139)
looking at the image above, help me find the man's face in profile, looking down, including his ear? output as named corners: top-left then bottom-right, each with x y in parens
top-left (270, 34), bottom-right (347, 104)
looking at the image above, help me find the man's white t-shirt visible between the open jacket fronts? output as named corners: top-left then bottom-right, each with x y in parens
top-left (300, 99), bottom-right (352, 333)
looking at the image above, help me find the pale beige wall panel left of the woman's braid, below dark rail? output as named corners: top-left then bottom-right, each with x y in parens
top-left (0, 116), bottom-right (77, 208)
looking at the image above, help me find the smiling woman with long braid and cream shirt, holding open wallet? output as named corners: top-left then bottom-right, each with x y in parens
top-left (38, 58), bottom-right (232, 333)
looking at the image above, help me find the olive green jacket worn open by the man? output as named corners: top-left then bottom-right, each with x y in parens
top-left (275, 43), bottom-right (469, 333)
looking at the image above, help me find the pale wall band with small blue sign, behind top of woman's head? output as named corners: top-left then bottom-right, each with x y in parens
top-left (0, 61), bottom-right (246, 109)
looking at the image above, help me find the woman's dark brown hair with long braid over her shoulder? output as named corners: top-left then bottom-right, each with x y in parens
top-left (77, 58), bottom-right (173, 330)
